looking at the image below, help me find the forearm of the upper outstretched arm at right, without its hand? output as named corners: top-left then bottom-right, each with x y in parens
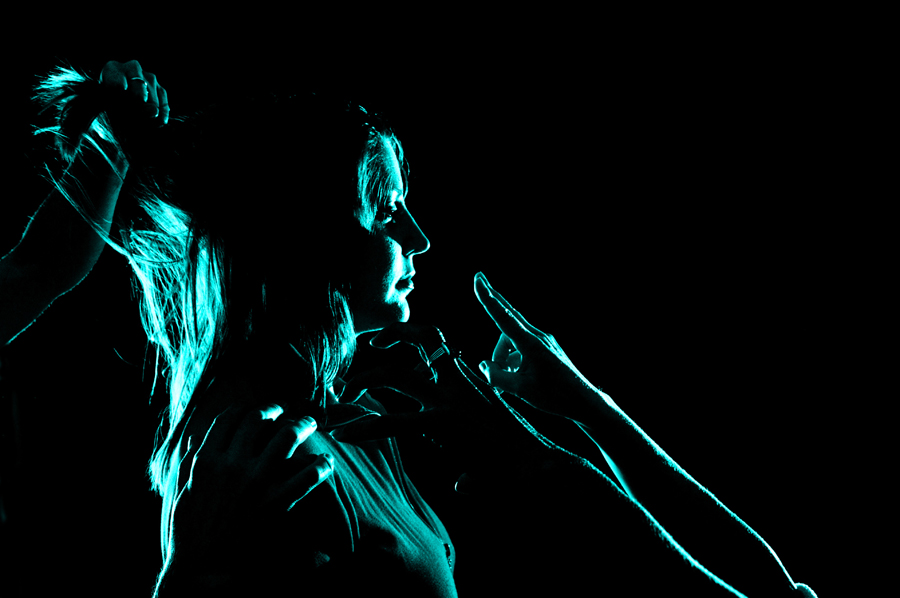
top-left (581, 393), bottom-right (793, 596)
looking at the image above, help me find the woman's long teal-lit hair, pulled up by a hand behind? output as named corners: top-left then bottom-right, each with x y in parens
top-left (35, 66), bottom-right (409, 580)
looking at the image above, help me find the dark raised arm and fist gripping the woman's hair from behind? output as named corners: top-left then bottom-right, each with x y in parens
top-left (0, 60), bottom-right (169, 345)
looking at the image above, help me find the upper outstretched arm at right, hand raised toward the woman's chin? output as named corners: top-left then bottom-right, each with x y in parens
top-left (475, 275), bottom-right (809, 597)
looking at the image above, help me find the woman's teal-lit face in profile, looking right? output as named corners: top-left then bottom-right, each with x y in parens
top-left (350, 145), bottom-right (431, 334)
